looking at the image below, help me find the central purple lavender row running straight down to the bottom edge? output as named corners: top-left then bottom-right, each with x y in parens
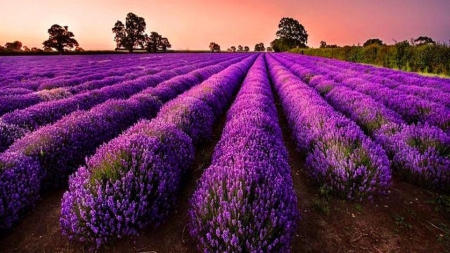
top-left (189, 56), bottom-right (299, 252)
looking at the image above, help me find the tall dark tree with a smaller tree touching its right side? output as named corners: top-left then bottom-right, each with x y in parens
top-left (112, 12), bottom-right (147, 53)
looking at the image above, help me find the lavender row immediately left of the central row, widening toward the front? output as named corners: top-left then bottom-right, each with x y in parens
top-left (61, 56), bottom-right (255, 247)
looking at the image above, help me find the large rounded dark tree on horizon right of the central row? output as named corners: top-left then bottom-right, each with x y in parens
top-left (276, 18), bottom-right (308, 49)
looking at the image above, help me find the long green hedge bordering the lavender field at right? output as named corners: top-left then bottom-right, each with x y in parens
top-left (294, 41), bottom-right (450, 76)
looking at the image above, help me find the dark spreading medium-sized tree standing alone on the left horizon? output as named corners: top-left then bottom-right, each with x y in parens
top-left (42, 24), bottom-right (79, 54)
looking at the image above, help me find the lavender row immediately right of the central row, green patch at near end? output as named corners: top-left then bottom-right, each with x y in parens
top-left (268, 56), bottom-right (391, 200)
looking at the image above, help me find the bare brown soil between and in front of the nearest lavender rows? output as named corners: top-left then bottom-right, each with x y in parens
top-left (0, 92), bottom-right (450, 253)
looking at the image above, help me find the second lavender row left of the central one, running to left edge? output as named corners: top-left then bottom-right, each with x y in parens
top-left (0, 53), bottom-right (253, 229)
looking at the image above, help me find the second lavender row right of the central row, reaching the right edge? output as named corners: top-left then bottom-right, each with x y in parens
top-left (278, 52), bottom-right (450, 192)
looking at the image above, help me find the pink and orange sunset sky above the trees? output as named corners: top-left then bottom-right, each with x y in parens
top-left (0, 0), bottom-right (450, 50)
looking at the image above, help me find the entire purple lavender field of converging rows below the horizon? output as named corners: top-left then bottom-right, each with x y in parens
top-left (0, 53), bottom-right (450, 252)
